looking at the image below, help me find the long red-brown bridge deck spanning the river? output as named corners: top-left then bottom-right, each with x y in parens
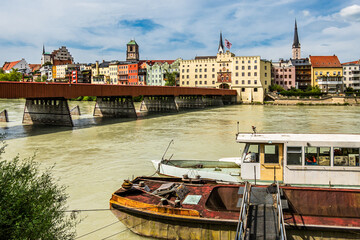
top-left (0, 82), bottom-right (237, 99)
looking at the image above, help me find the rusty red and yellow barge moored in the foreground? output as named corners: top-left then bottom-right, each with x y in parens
top-left (110, 177), bottom-right (360, 239)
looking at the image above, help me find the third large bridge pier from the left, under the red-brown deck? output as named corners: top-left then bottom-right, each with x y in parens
top-left (140, 96), bottom-right (178, 113)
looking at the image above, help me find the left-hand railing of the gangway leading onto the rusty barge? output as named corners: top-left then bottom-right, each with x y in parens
top-left (235, 182), bottom-right (251, 240)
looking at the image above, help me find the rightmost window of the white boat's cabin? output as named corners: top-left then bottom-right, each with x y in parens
top-left (334, 147), bottom-right (359, 166)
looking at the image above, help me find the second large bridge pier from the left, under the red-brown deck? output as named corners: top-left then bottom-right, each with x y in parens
top-left (94, 97), bottom-right (136, 118)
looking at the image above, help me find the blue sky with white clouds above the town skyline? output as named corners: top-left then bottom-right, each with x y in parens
top-left (0, 0), bottom-right (360, 66)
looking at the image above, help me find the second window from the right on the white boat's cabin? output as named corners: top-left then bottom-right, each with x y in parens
top-left (305, 147), bottom-right (330, 166)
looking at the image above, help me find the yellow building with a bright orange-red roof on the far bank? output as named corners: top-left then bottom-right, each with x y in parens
top-left (309, 55), bottom-right (344, 93)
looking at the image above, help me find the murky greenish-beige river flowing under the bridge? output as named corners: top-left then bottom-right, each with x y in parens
top-left (0, 99), bottom-right (360, 240)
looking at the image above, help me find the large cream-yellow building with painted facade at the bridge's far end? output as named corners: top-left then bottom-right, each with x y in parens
top-left (179, 51), bottom-right (271, 103)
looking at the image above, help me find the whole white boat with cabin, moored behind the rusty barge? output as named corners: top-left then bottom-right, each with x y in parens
top-left (152, 133), bottom-right (360, 188)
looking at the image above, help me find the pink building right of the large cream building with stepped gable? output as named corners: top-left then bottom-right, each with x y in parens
top-left (271, 60), bottom-right (297, 90)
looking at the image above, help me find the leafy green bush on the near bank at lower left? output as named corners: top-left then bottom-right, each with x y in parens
top-left (0, 143), bottom-right (79, 240)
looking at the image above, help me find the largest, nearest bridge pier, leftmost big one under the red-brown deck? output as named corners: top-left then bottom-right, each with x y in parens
top-left (23, 98), bottom-right (73, 127)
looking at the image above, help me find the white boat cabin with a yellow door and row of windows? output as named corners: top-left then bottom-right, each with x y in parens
top-left (237, 133), bottom-right (360, 187)
